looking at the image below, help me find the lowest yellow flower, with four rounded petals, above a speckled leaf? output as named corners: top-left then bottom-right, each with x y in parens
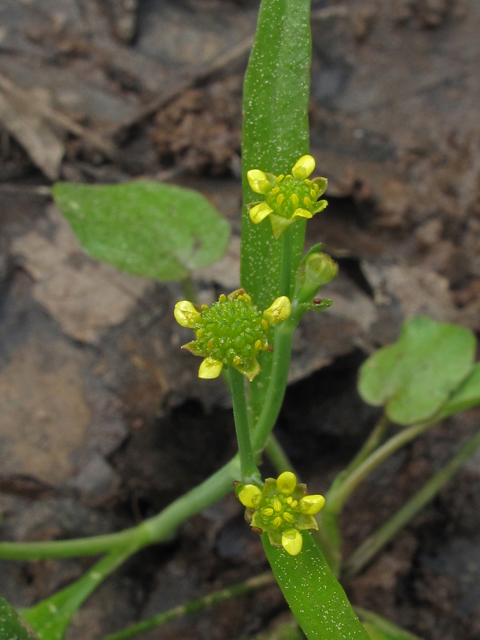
top-left (235, 471), bottom-right (325, 556)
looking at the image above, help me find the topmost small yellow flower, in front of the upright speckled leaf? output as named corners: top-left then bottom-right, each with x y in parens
top-left (247, 155), bottom-right (328, 238)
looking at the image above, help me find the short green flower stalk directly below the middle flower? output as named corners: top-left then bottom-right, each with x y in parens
top-left (230, 367), bottom-right (262, 486)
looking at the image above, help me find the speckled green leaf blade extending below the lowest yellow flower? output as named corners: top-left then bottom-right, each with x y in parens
top-left (262, 531), bottom-right (369, 640)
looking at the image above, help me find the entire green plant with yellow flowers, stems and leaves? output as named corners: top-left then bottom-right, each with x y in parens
top-left (0, 0), bottom-right (480, 640)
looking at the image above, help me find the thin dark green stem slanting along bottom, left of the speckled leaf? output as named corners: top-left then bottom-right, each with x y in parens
top-left (101, 571), bottom-right (276, 640)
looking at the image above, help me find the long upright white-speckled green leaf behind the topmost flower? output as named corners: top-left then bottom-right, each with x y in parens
top-left (240, 0), bottom-right (314, 415)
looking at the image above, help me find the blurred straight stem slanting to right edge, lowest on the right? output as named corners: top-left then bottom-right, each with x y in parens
top-left (343, 431), bottom-right (480, 581)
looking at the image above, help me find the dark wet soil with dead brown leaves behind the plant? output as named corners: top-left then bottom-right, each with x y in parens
top-left (0, 0), bottom-right (480, 640)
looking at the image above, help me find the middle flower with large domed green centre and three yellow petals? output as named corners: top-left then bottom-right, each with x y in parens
top-left (174, 289), bottom-right (291, 381)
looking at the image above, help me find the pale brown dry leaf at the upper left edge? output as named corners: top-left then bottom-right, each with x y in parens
top-left (0, 88), bottom-right (65, 180)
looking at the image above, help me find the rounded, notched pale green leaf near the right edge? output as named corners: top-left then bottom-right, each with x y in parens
top-left (358, 317), bottom-right (476, 425)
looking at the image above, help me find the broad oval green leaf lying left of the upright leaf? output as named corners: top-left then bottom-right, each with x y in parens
top-left (53, 182), bottom-right (230, 281)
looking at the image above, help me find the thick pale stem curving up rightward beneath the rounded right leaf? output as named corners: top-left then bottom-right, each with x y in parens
top-left (325, 421), bottom-right (435, 513)
